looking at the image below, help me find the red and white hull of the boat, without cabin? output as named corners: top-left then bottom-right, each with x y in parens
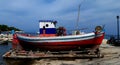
top-left (12, 33), bottom-right (104, 51)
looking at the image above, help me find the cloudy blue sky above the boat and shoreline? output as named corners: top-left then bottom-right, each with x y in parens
top-left (0, 0), bottom-right (120, 34)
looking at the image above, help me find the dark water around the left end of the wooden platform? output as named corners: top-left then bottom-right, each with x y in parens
top-left (0, 42), bottom-right (34, 65)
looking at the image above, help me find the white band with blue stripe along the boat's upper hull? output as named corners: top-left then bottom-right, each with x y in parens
top-left (17, 33), bottom-right (101, 43)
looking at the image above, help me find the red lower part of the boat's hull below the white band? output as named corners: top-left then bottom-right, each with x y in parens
top-left (13, 33), bottom-right (104, 51)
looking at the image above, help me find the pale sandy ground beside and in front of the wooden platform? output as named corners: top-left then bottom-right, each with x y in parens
top-left (33, 44), bottom-right (120, 65)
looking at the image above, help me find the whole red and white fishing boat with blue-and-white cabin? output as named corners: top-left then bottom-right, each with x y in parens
top-left (13, 20), bottom-right (104, 51)
